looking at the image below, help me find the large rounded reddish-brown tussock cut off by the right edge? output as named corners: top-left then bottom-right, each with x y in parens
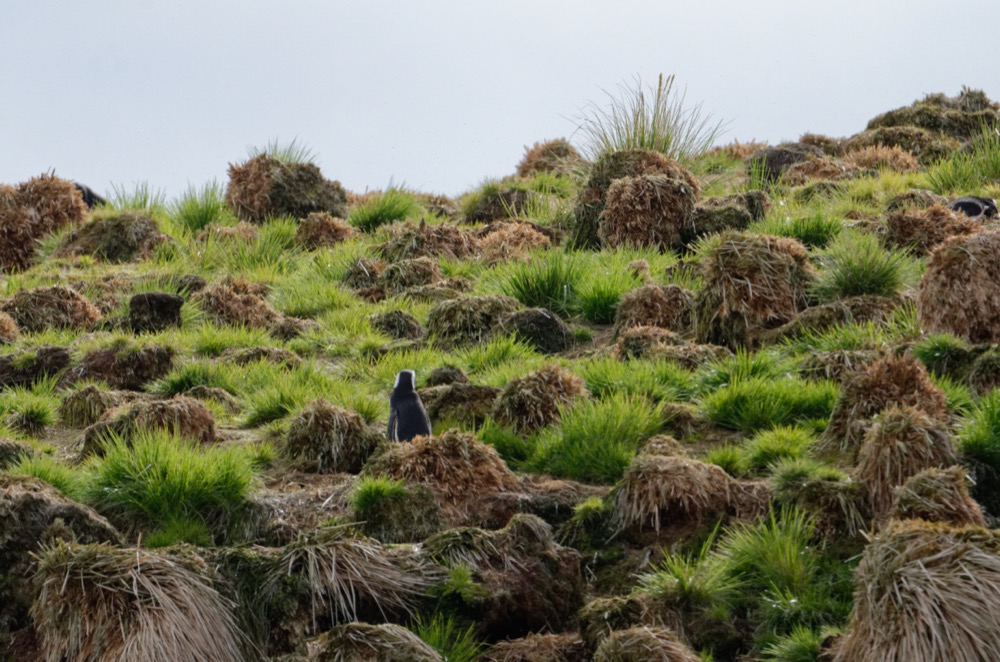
top-left (917, 232), bottom-right (1000, 343)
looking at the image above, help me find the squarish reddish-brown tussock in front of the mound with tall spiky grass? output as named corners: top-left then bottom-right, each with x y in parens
top-left (597, 175), bottom-right (697, 250)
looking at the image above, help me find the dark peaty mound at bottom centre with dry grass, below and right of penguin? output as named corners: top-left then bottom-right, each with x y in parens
top-left (422, 513), bottom-right (583, 641)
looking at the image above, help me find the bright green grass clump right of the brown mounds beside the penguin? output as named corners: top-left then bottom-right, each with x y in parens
top-left (530, 394), bottom-right (663, 484)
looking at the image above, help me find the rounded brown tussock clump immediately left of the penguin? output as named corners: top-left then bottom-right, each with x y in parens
top-left (285, 398), bottom-right (381, 473)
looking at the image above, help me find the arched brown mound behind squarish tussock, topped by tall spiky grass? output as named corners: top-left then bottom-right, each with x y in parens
top-left (567, 150), bottom-right (701, 249)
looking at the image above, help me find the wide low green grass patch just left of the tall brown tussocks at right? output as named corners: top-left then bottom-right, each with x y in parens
top-left (702, 377), bottom-right (838, 434)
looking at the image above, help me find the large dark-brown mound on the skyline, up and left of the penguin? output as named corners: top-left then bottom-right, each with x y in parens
top-left (226, 154), bottom-right (348, 223)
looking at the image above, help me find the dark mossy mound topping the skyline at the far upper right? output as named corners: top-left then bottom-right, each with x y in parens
top-left (866, 87), bottom-right (1000, 140)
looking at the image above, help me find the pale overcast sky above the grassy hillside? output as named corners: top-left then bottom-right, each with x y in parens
top-left (0, 0), bottom-right (1000, 198)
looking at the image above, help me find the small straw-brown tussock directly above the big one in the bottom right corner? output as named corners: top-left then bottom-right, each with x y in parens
top-left (890, 466), bottom-right (986, 526)
